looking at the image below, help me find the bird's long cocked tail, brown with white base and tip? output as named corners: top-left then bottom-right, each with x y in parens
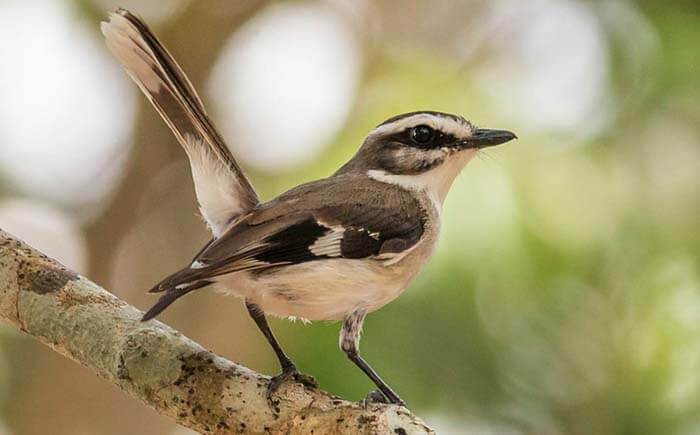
top-left (101, 9), bottom-right (258, 237)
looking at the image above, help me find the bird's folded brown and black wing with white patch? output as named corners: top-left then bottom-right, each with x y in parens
top-left (197, 177), bottom-right (427, 274)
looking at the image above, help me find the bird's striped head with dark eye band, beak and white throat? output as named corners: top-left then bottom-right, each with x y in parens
top-left (339, 111), bottom-right (516, 206)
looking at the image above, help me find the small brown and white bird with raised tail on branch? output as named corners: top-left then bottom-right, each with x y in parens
top-left (101, 9), bottom-right (516, 406)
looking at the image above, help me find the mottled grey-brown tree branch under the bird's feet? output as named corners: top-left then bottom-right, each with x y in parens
top-left (0, 230), bottom-right (434, 434)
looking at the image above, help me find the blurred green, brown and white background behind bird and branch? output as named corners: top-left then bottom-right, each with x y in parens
top-left (0, 0), bottom-right (700, 435)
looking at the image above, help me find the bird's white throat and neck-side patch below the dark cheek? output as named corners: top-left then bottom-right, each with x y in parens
top-left (367, 149), bottom-right (478, 210)
